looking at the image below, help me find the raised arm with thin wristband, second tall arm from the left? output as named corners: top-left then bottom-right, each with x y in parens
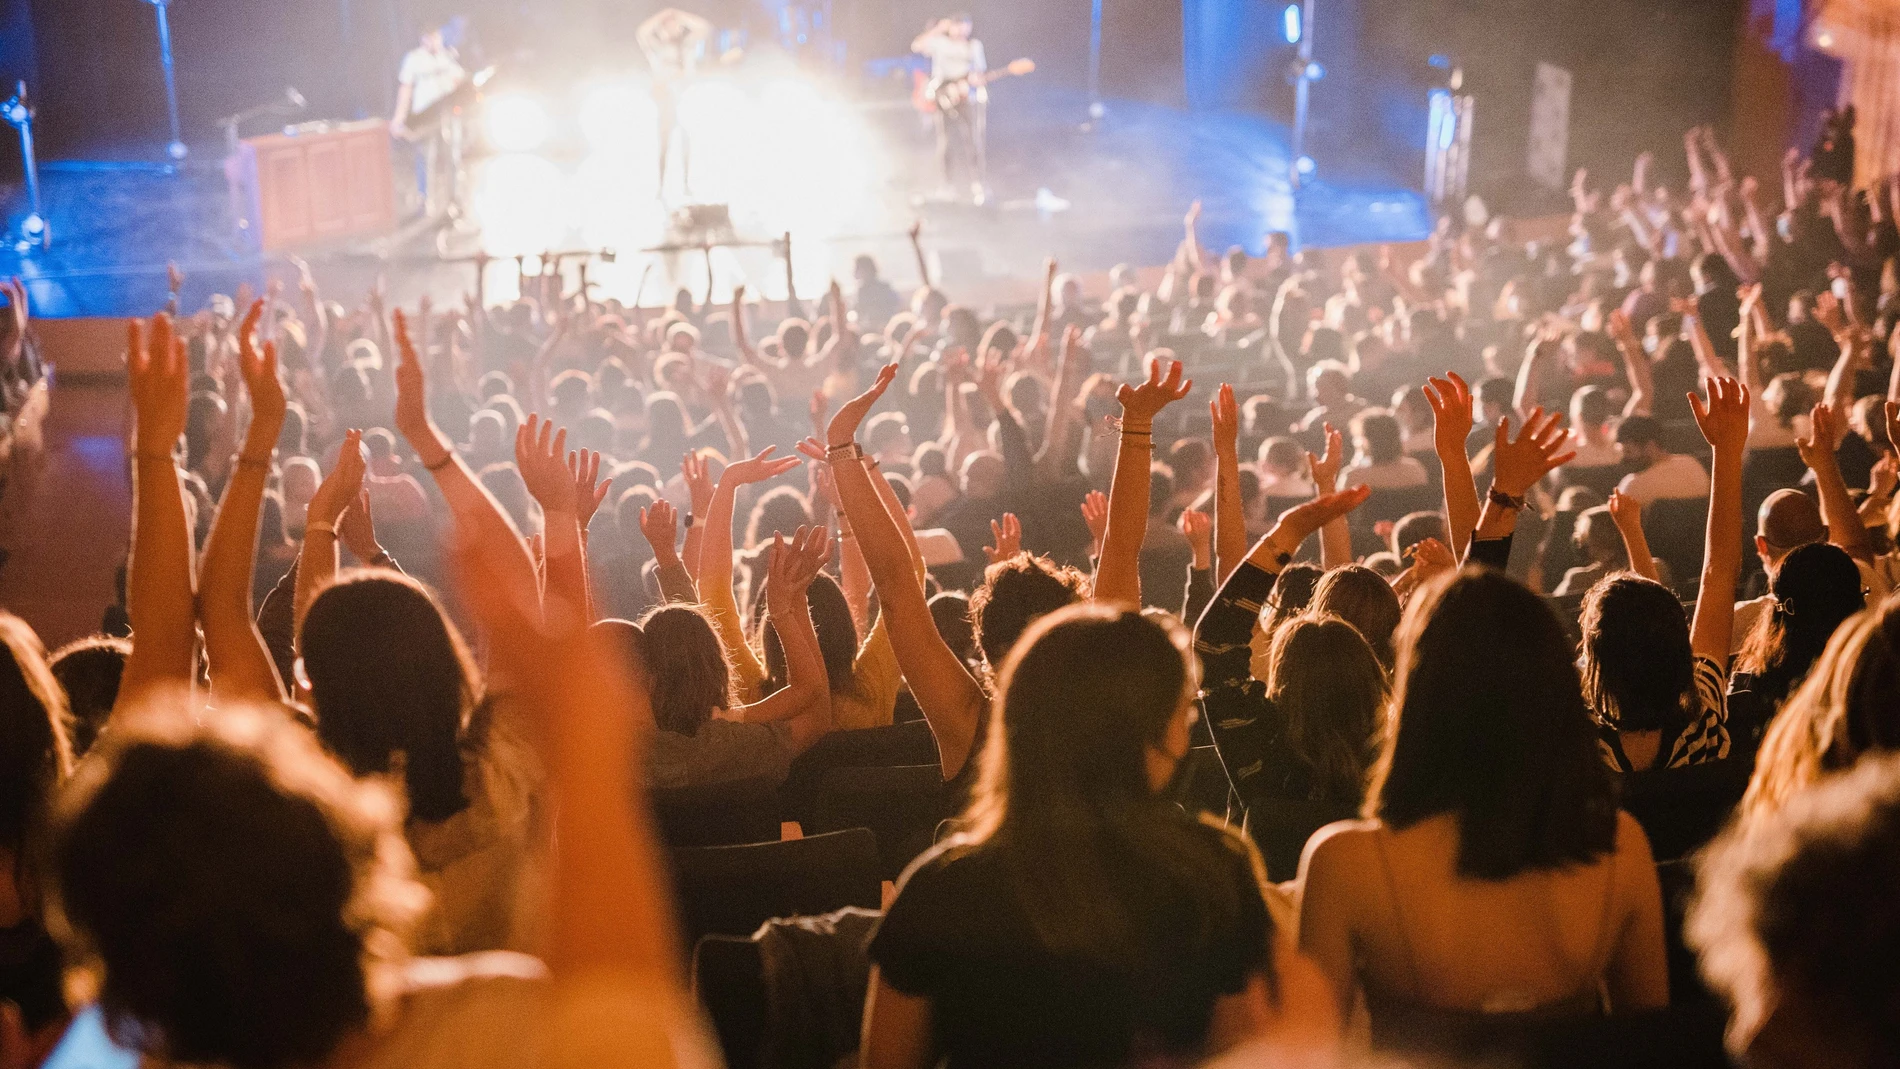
top-left (198, 302), bottom-right (285, 703)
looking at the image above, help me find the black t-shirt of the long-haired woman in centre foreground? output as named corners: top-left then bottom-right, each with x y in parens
top-left (870, 815), bottom-right (1273, 1069)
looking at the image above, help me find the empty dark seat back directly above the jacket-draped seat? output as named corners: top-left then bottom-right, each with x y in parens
top-left (673, 828), bottom-right (884, 946)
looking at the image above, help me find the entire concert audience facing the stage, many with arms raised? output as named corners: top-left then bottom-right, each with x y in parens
top-left (0, 108), bottom-right (1900, 1069)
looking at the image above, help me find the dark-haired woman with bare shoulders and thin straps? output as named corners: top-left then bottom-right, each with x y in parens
top-left (1300, 569), bottom-right (1668, 1056)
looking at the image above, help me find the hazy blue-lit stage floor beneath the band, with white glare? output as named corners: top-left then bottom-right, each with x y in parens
top-left (0, 80), bottom-right (1431, 317)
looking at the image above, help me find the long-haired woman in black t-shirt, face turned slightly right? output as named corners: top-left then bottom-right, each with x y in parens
top-left (863, 606), bottom-right (1324, 1069)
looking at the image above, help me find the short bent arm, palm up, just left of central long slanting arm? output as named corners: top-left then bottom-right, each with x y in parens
top-left (737, 526), bottom-right (832, 754)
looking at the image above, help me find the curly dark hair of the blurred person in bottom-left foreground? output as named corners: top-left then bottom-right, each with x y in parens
top-left (48, 703), bottom-right (428, 1069)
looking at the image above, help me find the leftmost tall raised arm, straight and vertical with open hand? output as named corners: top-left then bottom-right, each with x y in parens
top-left (112, 313), bottom-right (196, 716)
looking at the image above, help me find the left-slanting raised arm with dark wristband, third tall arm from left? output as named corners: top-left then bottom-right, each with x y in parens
top-left (395, 309), bottom-right (538, 618)
